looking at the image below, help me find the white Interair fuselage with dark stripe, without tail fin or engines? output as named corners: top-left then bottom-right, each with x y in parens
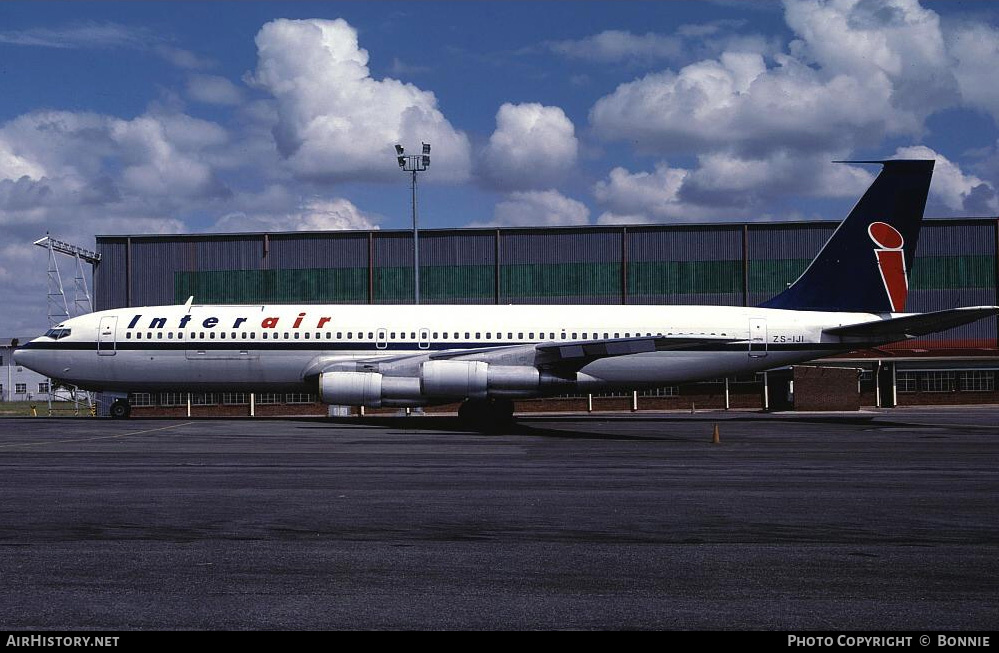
top-left (17, 305), bottom-right (879, 405)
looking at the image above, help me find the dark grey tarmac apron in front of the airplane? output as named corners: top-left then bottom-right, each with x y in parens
top-left (0, 407), bottom-right (999, 631)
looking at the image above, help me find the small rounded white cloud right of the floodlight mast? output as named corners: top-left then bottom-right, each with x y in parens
top-left (478, 103), bottom-right (579, 190)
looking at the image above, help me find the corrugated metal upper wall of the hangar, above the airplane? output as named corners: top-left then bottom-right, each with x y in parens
top-left (95, 219), bottom-right (997, 347)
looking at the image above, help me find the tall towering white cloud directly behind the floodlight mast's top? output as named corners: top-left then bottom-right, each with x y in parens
top-left (249, 19), bottom-right (471, 182)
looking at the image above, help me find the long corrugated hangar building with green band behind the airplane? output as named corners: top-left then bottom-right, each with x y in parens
top-left (94, 218), bottom-right (999, 414)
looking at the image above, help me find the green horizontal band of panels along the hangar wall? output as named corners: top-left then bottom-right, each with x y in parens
top-left (174, 255), bottom-right (995, 304)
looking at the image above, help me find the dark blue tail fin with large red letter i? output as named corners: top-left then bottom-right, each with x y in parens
top-left (760, 160), bottom-right (933, 313)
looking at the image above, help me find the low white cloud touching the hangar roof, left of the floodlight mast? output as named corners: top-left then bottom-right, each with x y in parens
top-left (208, 198), bottom-right (378, 231)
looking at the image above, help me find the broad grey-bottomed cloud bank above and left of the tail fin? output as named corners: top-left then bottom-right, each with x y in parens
top-left (590, 52), bottom-right (915, 156)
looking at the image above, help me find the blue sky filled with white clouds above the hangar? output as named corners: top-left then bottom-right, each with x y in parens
top-left (0, 0), bottom-right (999, 336)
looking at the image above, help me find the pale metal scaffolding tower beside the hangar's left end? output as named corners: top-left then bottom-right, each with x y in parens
top-left (34, 233), bottom-right (101, 415)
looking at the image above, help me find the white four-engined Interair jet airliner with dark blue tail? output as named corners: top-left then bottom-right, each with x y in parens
top-left (14, 159), bottom-right (999, 423)
